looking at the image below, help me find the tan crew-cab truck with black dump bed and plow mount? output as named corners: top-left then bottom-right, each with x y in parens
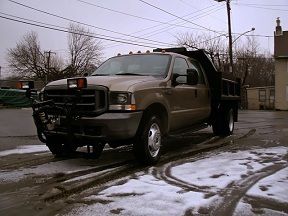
top-left (32, 48), bottom-right (240, 164)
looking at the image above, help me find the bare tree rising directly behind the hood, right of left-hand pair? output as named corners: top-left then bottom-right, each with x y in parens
top-left (67, 24), bottom-right (103, 75)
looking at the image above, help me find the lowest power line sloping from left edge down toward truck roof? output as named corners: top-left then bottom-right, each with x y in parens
top-left (0, 15), bottom-right (165, 48)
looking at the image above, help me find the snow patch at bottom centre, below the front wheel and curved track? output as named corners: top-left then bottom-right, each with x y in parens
top-left (70, 175), bottom-right (216, 216)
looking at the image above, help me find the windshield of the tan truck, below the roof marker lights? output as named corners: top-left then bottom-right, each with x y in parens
top-left (92, 54), bottom-right (171, 77)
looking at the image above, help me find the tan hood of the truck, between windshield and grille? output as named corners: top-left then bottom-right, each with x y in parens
top-left (47, 75), bottom-right (163, 91)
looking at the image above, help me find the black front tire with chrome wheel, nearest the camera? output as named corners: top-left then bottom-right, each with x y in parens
top-left (133, 115), bottom-right (163, 165)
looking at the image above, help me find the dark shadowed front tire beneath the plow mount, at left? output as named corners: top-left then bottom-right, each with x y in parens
top-left (46, 138), bottom-right (77, 156)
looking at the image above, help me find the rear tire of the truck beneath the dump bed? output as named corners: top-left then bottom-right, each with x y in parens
top-left (212, 108), bottom-right (234, 136)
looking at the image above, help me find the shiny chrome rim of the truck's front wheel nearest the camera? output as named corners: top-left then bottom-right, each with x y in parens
top-left (148, 123), bottom-right (161, 157)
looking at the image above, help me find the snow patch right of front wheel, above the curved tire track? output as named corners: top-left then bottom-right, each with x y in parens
top-left (171, 147), bottom-right (287, 189)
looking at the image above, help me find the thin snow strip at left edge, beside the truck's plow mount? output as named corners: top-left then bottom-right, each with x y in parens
top-left (0, 145), bottom-right (49, 157)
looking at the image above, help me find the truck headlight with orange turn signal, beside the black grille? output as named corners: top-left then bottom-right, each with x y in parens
top-left (109, 92), bottom-right (136, 110)
